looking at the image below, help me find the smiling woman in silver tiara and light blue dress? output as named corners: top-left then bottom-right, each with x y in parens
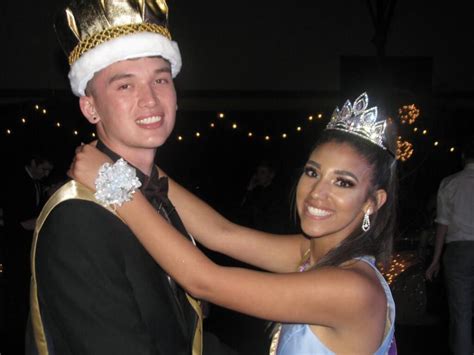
top-left (69, 94), bottom-right (397, 355)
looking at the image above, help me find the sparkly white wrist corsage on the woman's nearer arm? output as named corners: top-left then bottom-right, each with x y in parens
top-left (94, 158), bottom-right (142, 208)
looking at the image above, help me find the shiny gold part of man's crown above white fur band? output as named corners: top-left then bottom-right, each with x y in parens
top-left (55, 0), bottom-right (171, 65)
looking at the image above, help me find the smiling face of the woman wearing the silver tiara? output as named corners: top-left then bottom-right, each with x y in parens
top-left (296, 142), bottom-right (374, 242)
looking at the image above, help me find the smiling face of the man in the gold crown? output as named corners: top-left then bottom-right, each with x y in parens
top-left (80, 57), bottom-right (176, 156)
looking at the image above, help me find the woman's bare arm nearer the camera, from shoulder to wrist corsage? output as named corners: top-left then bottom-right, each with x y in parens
top-left (117, 193), bottom-right (385, 334)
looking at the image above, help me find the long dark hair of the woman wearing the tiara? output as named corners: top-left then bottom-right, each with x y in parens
top-left (306, 128), bottom-right (398, 267)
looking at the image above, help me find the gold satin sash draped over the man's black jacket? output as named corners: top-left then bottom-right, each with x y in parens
top-left (30, 181), bottom-right (203, 355)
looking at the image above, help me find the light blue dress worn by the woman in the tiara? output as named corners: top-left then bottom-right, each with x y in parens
top-left (276, 256), bottom-right (396, 355)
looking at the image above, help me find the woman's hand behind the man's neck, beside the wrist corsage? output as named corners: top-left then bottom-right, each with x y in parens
top-left (67, 142), bottom-right (112, 190)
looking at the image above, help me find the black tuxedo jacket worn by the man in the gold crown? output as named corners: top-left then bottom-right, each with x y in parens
top-left (27, 183), bottom-right (198, 355)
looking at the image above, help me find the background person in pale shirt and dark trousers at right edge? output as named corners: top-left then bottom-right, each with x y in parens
top-left (426, 138), bottom-right (474, 355)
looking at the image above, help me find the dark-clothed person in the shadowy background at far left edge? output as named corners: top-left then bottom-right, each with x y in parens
top-left (2, 153), bottom-right (53, 352)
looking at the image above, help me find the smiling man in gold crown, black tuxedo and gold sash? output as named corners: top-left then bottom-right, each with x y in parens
top-left (27, 0), bottom-right (202, 355)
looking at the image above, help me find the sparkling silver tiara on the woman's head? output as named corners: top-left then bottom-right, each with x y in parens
top-left (326, 92), bottom-right (387, 150)
